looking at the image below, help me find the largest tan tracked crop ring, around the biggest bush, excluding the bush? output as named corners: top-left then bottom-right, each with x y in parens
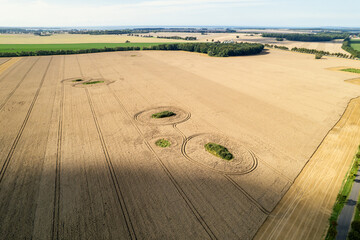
top-left (184, 134), bottom-right (257, 174)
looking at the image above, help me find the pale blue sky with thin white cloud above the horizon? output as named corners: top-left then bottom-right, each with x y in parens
top-left (0, 0), bottom-right (360, 27)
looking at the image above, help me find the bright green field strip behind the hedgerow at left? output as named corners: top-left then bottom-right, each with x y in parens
top-left (0, 43), bottom-right (172, 52)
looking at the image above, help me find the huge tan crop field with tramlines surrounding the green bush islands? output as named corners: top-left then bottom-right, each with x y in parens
top-left (0, 51), bottom-right (360, 239)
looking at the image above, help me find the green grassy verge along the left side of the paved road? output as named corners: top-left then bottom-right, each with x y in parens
top-left (325, 146), bottom-right (360, 240)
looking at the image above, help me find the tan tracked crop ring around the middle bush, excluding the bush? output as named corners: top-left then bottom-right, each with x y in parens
top-left (134, 106), bottom-right (190, 125)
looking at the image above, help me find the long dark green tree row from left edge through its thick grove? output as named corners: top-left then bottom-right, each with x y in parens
top-left (0, 43), bottom-right (264, 57)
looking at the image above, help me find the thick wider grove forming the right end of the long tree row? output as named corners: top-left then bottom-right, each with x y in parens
top-left (143, 43), bottom-right (264, 57)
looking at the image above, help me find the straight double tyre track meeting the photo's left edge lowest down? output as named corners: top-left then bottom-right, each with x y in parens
top-left (0, 57), bottom-right (53, 183)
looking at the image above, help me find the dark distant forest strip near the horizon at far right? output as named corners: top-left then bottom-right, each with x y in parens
top-left (262, 33), bottom-right (349, 42)
